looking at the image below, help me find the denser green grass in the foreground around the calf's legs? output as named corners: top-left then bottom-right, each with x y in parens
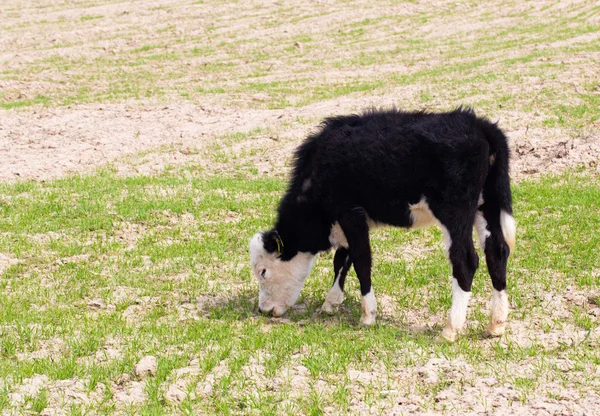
top-left (0, 167), bottom-right (600, 414)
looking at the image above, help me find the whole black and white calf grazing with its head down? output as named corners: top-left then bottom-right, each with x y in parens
top-left (250, 108), bottom-right (515, 341)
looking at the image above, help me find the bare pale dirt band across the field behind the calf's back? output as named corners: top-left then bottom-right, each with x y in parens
top-left (0, 95), bottom-right (600, 181)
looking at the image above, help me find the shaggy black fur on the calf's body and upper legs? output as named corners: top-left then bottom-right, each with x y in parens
top-left (263, 108), bottom-right (512, 295)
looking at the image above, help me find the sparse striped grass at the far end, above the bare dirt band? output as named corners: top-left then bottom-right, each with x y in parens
top-left (0, 1), bottom-right (600, 128)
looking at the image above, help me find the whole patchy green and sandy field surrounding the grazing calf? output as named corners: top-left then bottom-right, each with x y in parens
top-left (0, 0), bottom-right (600, 415)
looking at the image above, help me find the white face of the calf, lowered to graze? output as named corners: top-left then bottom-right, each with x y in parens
top-left (250, 232), bottom-right (316, 316)
